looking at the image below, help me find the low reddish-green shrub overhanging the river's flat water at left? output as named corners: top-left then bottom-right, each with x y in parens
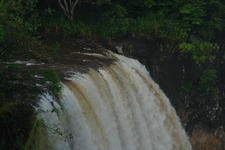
top-left (3, 32), bottom-right (58, 61)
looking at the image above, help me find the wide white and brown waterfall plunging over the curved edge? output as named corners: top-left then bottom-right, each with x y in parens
top-left (38, 52), bottom-right (192, 150)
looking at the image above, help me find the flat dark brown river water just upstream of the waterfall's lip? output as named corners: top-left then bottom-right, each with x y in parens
top-left (13, 41), bottom-right (114, 80)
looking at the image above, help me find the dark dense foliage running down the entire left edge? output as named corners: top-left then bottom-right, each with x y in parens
top-left (0, 0), bottom-right (60, 150)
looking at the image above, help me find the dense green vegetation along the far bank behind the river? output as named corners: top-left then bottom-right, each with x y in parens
top-left (38, 0), bottom-right (225, 42)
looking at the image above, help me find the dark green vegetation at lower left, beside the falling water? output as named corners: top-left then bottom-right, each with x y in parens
top-left (0, 64), bottom-right (41, 149)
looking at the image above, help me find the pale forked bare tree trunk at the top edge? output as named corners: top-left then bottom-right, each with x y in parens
top-left (58, 0), bottom-right (79, 20)
